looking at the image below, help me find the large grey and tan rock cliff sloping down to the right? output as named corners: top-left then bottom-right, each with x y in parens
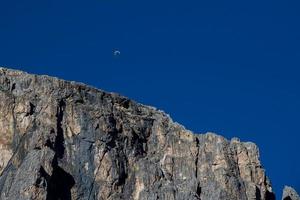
top-left (0, 68), bottom-right (290, 200)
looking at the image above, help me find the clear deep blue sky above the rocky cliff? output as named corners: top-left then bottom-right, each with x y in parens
top-left (0, 0), bottom-right (300, 197)
